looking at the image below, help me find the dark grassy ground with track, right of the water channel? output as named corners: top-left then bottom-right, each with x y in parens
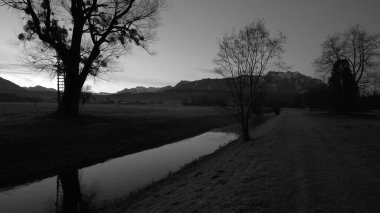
top-left (116, 110), bottom-right (380, 212)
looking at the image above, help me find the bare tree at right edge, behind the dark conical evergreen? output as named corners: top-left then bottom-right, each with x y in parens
top-left (314, 25), bottom-right (380, 92)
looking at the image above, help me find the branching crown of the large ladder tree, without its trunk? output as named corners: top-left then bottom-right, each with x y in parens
top-left (2, 0), bottom-right (165, 75)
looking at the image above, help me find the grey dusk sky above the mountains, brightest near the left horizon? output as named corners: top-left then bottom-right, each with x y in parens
top-left (0, 0), bottom-right (380, 92)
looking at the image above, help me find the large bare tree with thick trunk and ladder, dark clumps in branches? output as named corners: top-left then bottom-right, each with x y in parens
top-left (0, 0), bottom-right (165, 115)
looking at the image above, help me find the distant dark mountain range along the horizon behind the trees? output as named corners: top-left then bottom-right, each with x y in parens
top-left (0, 71), bottom-right (324, 104)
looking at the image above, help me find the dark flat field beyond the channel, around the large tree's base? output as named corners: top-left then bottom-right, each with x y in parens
top-left (0, 103), bottom-right (233, 187)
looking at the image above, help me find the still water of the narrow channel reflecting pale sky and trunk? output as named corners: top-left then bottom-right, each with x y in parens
top-left (0, 132), bottom-right (237, 213)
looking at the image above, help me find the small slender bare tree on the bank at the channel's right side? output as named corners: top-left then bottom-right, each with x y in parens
top-left (214, 20), bottom-right (286, 140)
